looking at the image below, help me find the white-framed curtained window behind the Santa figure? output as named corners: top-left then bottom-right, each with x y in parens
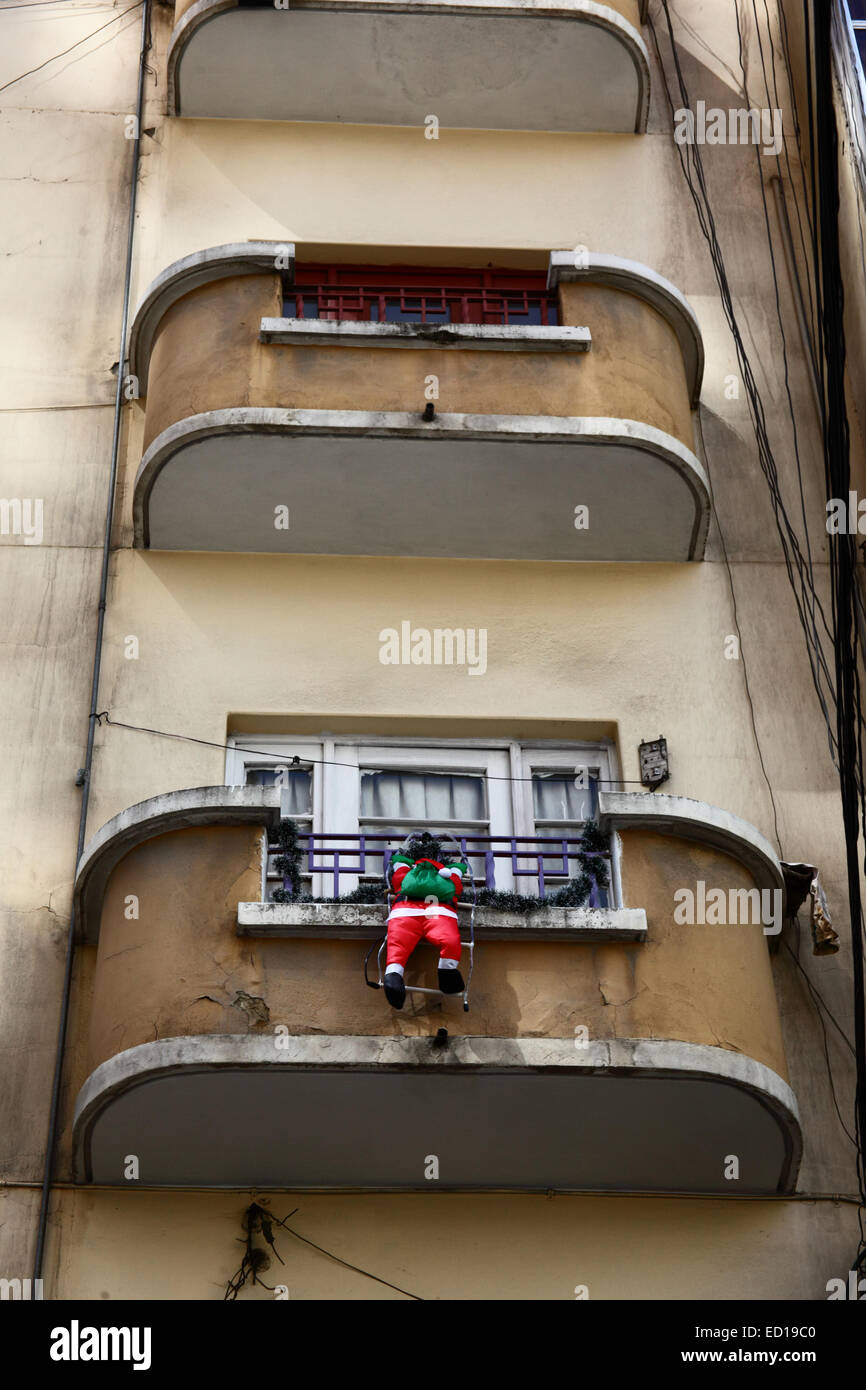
top-left (227, 734), bottom-right (616, 901)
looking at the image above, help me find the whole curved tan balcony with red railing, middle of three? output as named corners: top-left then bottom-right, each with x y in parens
top-left (129, 242), bottom-right (709, 560)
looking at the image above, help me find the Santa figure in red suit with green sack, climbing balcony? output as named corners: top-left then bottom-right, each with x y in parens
top-left (384, 837), bottom-right (468, 1009)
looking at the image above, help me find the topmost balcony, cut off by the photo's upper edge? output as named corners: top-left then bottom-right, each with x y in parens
top-left (168, 0), bottom-right (649, 132)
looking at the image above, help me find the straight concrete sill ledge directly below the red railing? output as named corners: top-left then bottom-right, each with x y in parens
top-left (259, 318), bottom-right (592, 352)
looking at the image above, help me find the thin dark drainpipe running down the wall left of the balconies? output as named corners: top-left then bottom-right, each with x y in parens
top-left (33, 0), bottom-right (150, 1279)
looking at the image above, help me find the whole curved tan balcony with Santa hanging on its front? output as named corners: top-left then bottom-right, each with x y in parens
top-left (74, 787), bottom-right (801, 1194)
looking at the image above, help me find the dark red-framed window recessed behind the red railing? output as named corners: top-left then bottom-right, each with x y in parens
top-left (284, 264), bottom-right (559, 325)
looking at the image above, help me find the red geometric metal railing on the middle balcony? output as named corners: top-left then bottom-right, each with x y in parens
top-left (282, 284), bottom-right (559, 327)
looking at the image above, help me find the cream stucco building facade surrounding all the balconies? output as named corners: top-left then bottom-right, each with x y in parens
top-left (0, 0), bottom-right (860, 1298)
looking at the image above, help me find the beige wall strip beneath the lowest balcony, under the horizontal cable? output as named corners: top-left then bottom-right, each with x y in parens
top-left (40, 1188), bottom-right (853, 1301)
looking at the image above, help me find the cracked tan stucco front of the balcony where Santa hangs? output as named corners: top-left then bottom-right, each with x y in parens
top-left (77, 827), bottom-right (787, 1079)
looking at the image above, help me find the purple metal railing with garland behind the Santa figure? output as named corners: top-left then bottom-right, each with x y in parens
top-left (267, 830), bottom-right (610, 908)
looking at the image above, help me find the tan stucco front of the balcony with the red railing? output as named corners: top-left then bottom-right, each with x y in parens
top-left (143, 274), bottom-right (695, 449)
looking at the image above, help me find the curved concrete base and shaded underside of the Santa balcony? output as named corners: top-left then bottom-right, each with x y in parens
top-left (74, 1030), bottom-right (801, 1194)
